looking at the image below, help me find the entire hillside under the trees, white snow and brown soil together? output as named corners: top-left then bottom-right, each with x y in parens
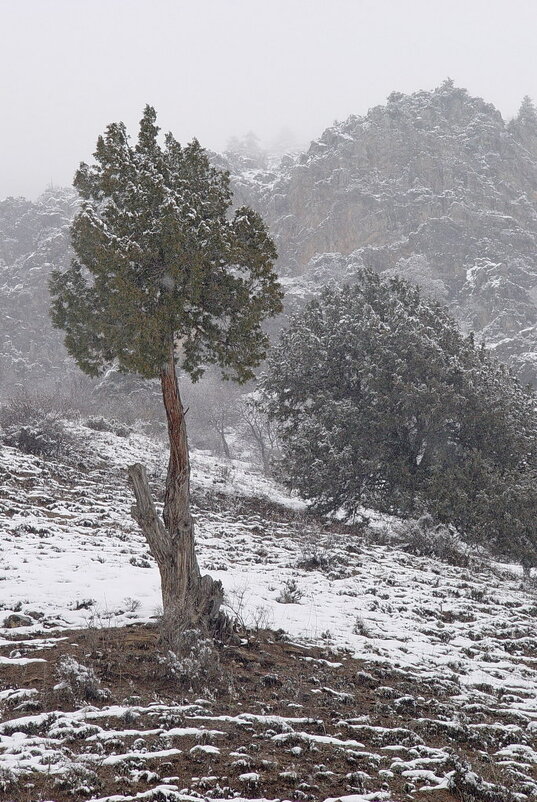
top-left (0, 424), bottom-right (537, 802)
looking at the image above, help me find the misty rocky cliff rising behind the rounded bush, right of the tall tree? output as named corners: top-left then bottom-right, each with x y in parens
top-left (235, 81), bottom-right (537, 381)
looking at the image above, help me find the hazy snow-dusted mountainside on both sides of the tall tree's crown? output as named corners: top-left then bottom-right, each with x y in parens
top-left (0, 80), bottom-right (537, 386)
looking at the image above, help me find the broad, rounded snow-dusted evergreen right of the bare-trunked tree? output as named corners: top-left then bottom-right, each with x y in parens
top-left (265, 270), bottom-right (537, 560)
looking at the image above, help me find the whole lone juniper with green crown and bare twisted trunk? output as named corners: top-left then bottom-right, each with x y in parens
top-left (50, 106), bottom-right (281, 626)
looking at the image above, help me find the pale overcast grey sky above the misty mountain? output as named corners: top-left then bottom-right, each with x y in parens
top-left (0, 0), bottom-right (537, 198)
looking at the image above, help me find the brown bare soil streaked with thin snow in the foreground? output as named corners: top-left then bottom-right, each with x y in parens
top-left (0, 625), bottom-right (537, 802)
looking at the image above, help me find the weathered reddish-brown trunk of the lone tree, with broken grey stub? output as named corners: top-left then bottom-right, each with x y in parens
top-left (129, 346), bottom-right (223, 628)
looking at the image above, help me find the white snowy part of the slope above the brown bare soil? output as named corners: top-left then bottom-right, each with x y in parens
top-left (0, 424), bottom-right (537, 802)
